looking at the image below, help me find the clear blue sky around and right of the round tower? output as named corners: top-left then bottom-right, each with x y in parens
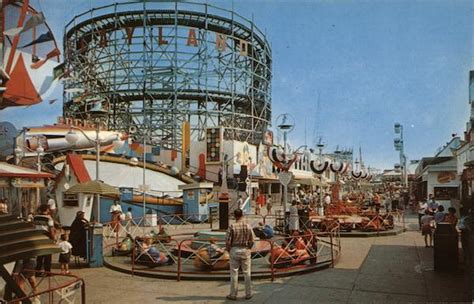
top-left (0, 0), bottom-right (474, 169)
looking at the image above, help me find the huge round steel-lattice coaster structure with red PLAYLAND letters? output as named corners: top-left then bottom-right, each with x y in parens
top-left (64, 1), bottom-right (272, 149)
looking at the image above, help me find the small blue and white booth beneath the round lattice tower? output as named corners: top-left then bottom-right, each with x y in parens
top-left (178, 183), bottom-right (214, 222)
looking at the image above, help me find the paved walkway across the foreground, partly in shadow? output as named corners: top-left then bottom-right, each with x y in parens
top-left (73, 216), bottom-right (471, 304)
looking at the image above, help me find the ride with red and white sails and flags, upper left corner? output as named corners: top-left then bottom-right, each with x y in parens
top-left (0, 0), bottom-right (61, 109)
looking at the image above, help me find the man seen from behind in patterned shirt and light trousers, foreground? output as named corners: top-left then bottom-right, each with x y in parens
top-left (226, 209), bottom-right (254, 301)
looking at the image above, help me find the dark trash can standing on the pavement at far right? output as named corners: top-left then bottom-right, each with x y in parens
top-left (433, 223), bottom-right (459, 271)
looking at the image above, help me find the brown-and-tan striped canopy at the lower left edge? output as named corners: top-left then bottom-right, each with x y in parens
top-left (0, 215), bottom-right (61, 265)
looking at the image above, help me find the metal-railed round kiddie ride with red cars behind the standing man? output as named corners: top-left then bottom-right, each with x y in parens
top-left (103, 215), bottom-right (341, 281)
